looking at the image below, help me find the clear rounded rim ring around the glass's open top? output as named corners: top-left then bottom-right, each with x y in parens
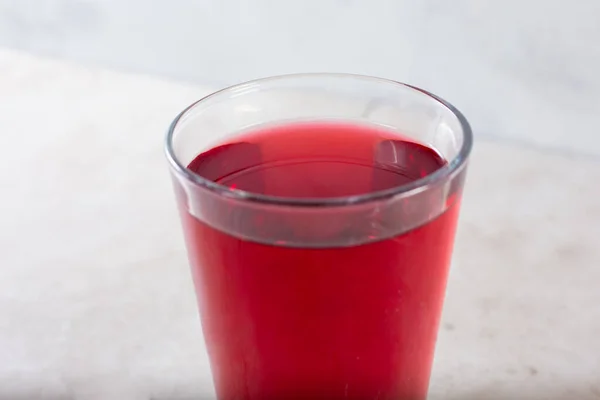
top-left (165, 72), bottom-right (473, 207)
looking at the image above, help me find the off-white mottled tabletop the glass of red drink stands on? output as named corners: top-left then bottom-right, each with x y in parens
top-left (0, 51), bottom-right (600, 400)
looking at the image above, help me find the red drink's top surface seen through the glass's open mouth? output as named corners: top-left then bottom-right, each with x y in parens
top-left (189, 124), bottom-right (445, 198)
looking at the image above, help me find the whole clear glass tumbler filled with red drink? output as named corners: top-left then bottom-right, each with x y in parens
top-left (166, 74), bottom-right (472, 400)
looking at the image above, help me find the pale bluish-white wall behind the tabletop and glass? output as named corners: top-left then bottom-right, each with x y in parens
top-left (0, 0), bottom-right (600, 155)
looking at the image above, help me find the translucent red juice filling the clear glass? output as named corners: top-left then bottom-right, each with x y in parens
top-left (182, 123), bottom-right (458, 400)
